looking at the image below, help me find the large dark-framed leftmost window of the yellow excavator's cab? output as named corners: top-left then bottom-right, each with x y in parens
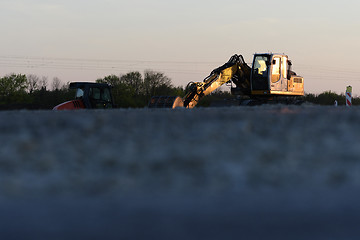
top-left (252, 55), bottom-right (270, 90)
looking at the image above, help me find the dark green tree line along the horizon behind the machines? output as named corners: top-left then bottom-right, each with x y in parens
top-left (0, 70), bottom-right (360, 110)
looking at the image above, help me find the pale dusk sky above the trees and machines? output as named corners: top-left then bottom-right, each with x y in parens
top-left (0, 0), bottom-right (360, 95)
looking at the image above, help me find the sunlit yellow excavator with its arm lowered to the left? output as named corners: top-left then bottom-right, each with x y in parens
top-left (148, 53), bottom-right (304, 108)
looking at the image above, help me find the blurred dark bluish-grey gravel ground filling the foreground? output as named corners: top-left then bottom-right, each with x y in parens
top-left (0, 105), bottom-right (360, 240)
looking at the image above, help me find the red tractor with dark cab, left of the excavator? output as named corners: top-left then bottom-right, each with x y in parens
top-left (54, 82), bottom-right (114, 110)
